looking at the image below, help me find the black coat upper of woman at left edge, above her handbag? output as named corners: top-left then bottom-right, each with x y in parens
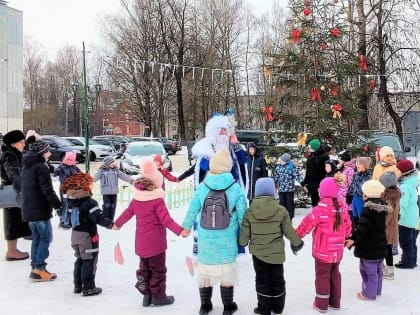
top-left (0, 144), bottom-right (22, 191)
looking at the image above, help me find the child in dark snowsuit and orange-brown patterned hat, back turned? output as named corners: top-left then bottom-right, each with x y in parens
top-left (61, 173), bottom-right (113, 296)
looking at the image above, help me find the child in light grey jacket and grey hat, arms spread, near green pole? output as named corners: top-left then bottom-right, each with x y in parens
top-left (93, 156), bottom-right (133, 221)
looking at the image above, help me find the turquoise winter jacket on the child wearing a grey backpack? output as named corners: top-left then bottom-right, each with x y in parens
top-left (182, 173), bottom-right (247, 265)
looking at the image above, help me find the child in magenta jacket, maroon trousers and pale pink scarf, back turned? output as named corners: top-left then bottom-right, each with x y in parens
top-left (114, 174), bottom-right (189, 307)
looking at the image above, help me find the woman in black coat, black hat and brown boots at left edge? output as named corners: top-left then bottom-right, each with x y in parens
top-left (0, 130), bottom-right (31, 261)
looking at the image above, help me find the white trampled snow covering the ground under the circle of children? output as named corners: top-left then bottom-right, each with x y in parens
top-left (0, 175), bottom-right (420, 315)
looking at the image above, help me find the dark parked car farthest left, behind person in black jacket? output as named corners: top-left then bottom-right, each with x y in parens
top-left (41, 135), bottom-right (85, 163)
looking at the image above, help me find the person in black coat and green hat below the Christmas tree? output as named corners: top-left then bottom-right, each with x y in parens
top-left (302, 139), bottom-right (330, 207)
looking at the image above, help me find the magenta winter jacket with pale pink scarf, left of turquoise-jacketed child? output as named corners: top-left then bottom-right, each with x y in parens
top-left (115, 188), bottom-right (182, 258)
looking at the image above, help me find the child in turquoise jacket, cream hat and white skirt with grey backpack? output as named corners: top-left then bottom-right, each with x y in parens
top-left (182, 149), bottom-right (247, 315)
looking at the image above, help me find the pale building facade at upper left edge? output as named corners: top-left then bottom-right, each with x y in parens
top-left (0, 0), bottom-right (23, 134)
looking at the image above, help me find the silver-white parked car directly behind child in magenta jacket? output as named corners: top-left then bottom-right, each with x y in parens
top-left (120, 141), bottom-right (172, 175)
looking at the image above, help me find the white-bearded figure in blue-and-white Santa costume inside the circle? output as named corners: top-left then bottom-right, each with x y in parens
top-left (191, 110), bottom-right (249, 254)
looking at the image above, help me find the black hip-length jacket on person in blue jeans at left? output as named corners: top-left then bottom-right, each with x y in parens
top-left (20, 151), bottom-right (61, 222)
